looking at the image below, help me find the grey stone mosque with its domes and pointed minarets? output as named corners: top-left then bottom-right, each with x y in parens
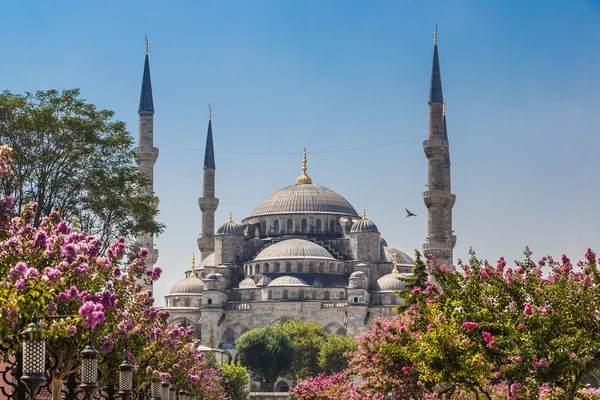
top-left (135, 31), bottom-right (456, 349)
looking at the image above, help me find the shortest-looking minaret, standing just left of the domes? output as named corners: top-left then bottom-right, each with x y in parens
top-left (198, 104), bottom-right (219, 260)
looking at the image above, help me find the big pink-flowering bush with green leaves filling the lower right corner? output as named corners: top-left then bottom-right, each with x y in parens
top-left (295, 250), bottom-right (600, 400)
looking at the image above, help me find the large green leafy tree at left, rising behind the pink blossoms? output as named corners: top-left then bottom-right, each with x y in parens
top-left (0, 89), bottom-right (164, 250)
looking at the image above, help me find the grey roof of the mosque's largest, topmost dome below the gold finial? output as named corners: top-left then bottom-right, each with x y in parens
top-left (251, 183), bottom-right (358, 217)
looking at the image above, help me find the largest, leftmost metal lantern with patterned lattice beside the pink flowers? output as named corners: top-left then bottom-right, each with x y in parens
top-left (21, 317), bottom-right (46, 399)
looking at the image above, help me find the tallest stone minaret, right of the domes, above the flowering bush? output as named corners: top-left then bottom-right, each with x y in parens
top-left (423, 27), bottom-right (456, 265)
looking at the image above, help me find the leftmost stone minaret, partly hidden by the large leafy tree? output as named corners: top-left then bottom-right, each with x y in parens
top-left (133, 36), bottom-right (158, 276)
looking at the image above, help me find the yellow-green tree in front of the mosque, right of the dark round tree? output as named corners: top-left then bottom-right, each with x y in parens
top-left (277, 320), bottom-right (329, 379)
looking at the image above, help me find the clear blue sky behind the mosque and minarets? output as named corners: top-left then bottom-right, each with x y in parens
top-left (0, 0), bottom-right (600, 304)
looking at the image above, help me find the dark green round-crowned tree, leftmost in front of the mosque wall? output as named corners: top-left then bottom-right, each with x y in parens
top-left (235, 326), bottom-right (294, 392)
